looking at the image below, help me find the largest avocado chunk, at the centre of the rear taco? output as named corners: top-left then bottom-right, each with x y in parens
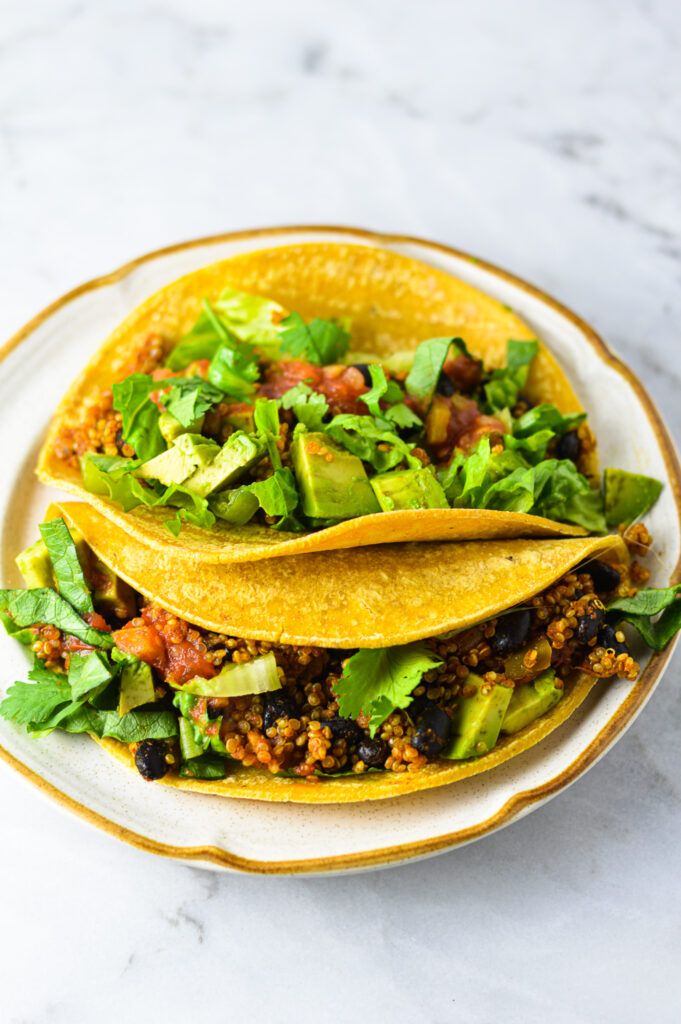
top-left (291, 433), bottom-right (381, 519)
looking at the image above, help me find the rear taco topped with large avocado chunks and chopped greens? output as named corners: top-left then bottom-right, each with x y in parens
top-left (38, 244), bottom-right (659, 562)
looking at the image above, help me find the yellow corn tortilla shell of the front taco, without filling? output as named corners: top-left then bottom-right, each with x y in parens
top-left (47, 502), bottom-right (627, 804)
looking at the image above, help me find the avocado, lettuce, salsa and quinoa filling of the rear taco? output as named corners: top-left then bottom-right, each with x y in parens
top-left (50, 280), bottom-right (661, 536)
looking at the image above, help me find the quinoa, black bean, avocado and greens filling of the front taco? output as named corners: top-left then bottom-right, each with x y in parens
top-left (0, 518), bottom-right (681, 780)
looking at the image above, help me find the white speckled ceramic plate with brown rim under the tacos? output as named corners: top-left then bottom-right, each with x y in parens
top-left (0, 227), bottom-right (681, 874)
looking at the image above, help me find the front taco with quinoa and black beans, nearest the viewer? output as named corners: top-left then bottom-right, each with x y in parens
top-left (0, 503), bottom-right (681, 803)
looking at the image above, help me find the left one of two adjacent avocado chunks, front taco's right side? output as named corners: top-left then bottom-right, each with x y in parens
top-left (443, 673), bottom-right (513, 761)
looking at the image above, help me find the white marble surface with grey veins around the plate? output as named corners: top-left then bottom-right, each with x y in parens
top-left (0, 0), bottom-right (681, 1024)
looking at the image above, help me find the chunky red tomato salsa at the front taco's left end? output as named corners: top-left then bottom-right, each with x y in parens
top-left (114, 605), bottom-right (217, 685)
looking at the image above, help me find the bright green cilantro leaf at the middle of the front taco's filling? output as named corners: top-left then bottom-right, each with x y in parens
top-left (334, 640), bottom-right (442, 736)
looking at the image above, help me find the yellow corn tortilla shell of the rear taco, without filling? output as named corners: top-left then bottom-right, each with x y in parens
top-left (38, 243), bottom-right (584, 563)
